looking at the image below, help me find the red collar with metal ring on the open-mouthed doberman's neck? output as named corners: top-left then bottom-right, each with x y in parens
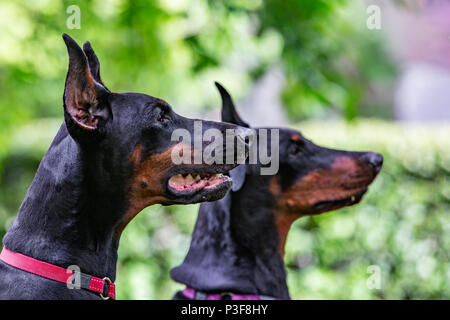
top-left (0, 247), bottom-right (116, 299)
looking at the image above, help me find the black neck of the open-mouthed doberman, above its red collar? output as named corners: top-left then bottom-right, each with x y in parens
top-left (3, 124), bottom-right (125, 281)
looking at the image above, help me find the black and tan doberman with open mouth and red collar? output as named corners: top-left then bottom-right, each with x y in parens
top-left (0, 34), bottom-right (248, 299)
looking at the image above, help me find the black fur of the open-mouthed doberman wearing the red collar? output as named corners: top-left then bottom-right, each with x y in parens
top-left (0, 35), bottom-right (246, 299)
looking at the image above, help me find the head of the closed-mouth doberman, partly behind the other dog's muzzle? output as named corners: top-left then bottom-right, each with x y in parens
top-left (216, 84), bottom-right (383, 252)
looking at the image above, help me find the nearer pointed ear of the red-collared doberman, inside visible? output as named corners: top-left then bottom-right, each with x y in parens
top-left (63, 34), bottom-right (111, 138)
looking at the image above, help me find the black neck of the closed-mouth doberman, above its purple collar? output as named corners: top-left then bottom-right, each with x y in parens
top-left (171, 179), bottom-right (289, 299)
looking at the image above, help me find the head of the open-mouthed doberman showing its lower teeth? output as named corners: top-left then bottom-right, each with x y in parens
top-left (63, 35), bottom-right (250, 238)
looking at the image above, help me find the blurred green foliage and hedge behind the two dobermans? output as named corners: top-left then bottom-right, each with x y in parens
top-left (0, 0), bottom-right (450, 299)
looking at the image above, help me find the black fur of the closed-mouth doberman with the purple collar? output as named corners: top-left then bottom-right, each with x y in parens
top-left (171, 85), bottom-right (382, 299)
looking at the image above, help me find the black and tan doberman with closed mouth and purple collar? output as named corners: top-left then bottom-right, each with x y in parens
top-left (171, 83), bottom-right (383, 300)
